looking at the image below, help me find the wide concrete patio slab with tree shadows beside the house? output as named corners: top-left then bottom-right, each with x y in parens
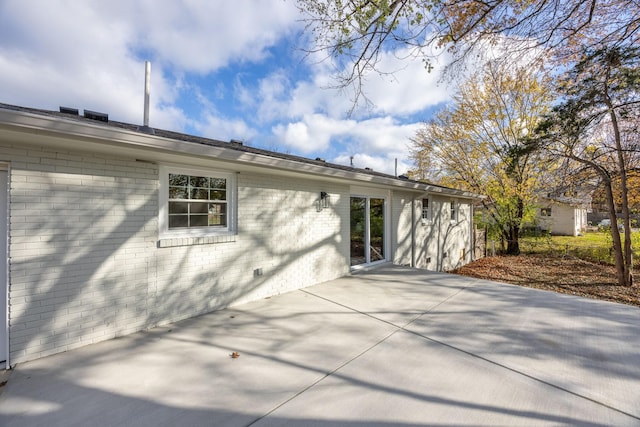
top-left (0, 267), bottom-right (640, 427)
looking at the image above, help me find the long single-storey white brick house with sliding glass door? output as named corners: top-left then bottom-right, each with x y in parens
top-left (0, 104), bottom-right (478, 365)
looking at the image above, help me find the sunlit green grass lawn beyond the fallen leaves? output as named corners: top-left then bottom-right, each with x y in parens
top-left (520, 232), bottom-right (640, 266)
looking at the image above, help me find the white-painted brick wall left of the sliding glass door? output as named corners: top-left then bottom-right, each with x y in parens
top-left (0, 144), bottom-right (349, 364)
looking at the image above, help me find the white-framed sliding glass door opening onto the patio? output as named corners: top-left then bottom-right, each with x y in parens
top-left (351, 196), bottom-right (386, 266)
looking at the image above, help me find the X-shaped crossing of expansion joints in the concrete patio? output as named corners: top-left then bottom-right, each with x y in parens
top-left (296, 280), bottom-right (640, 424)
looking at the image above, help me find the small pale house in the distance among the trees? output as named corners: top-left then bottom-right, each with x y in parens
top-left (536, 196), bottom-right (590, 236)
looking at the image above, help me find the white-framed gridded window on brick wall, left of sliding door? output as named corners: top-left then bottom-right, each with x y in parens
top-left (159, 166), bottom-right (236, 238)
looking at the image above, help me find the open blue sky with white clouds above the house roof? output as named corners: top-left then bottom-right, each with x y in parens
top-left (0, 0), bottom-right (449, 173)
